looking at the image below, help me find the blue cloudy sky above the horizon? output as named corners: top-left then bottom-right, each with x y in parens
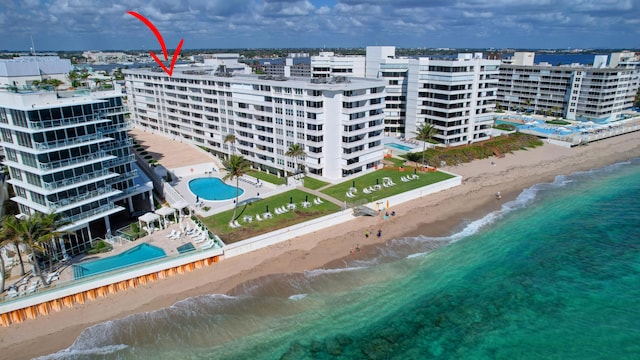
top-left (0, 0), bottom-right (640, 51)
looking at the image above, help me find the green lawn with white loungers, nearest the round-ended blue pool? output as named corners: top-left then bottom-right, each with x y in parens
top-left (201, 190), bottom-right (340, 244)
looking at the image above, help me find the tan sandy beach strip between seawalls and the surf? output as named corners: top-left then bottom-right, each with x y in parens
top-left (0, 132), bottom-right (640, 359)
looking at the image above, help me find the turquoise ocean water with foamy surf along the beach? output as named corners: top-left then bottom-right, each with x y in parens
top-left (42, 159), bottom-right (640, 360)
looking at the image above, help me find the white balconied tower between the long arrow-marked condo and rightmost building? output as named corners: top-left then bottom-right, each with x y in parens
top-left (405, 53), bottom-right (500, 146)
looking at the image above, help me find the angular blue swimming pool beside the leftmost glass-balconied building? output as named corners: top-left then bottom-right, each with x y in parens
top-left (73, 243), bottom-right (167, 280)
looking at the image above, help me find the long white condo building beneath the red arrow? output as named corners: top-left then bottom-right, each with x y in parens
top-left (124, 67), bottom-right (385, 181)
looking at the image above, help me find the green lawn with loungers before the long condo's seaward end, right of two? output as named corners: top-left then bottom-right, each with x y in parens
top-left (322, 167), bottom-right (453, 203)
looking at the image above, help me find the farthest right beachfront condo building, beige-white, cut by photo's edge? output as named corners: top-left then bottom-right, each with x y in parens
top-left (497, 53), bottom-right (640, 121)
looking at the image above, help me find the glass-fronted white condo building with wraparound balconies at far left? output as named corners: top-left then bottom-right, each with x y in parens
top-left (0, 56), bottom-right (152, 258)
